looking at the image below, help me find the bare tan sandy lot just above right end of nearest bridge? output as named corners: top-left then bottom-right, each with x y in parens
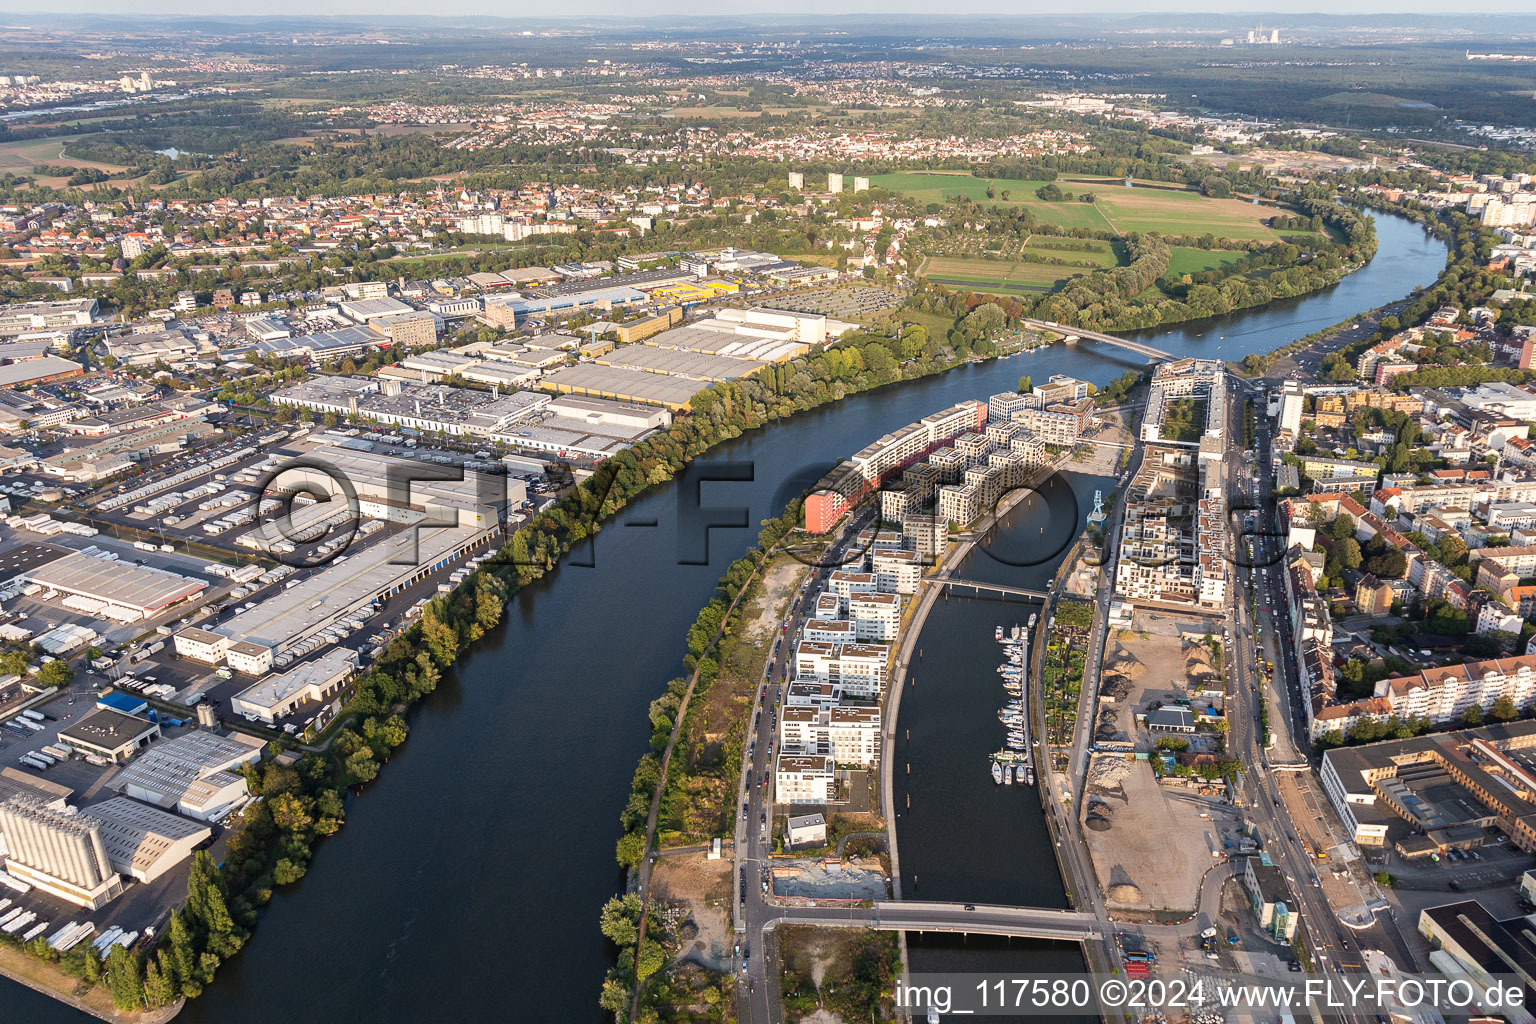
top-left (1083, 754), bottom-right (1224, 910)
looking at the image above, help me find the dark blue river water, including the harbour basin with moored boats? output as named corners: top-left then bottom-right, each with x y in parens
top-left (12, 216), bottom-right (1445, 1024)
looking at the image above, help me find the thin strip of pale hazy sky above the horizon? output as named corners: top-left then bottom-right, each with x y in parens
top-left (0, 0), bottom-right (1519, 16)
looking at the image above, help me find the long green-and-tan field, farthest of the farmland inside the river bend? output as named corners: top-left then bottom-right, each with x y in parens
top-left (869, 170), bottom-right (1279, 241)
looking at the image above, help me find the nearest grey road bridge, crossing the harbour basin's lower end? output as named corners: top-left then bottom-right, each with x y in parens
top-left (771, 900), bottom-right (1103, 943)
